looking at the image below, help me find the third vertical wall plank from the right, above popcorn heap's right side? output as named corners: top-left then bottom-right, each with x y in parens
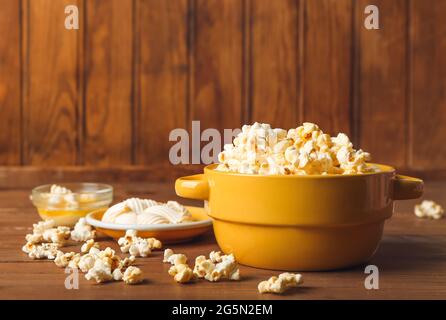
top-left (303, 0), bottom-right (353, 135)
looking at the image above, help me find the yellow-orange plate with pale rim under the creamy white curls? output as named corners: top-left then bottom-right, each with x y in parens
top-left (86, 207), bottom-right (212, 242)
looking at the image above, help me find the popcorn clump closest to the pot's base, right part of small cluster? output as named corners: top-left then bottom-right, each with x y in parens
top-left (193, 252), bottom-right (240, 281)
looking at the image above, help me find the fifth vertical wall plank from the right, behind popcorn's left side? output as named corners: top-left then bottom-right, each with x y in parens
top-left (191, 0), bottom-right (243, 130)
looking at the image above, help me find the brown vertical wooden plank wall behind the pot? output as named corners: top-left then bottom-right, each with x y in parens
top-left (0, 0), bottom-right (446, 177)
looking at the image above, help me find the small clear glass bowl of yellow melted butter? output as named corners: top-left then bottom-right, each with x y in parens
top-left (30, 183), bottom-right (113, 226)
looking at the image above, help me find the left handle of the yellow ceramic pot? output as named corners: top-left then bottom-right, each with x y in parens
top-left (175, 174), bottom-right (209, 200)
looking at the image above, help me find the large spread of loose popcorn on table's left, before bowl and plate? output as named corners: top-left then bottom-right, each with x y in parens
top-left (22, 218), bottom-right (148, 284)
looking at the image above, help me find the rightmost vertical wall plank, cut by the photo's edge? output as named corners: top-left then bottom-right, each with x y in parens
top-left (409, 0), bottom-right (446, 169)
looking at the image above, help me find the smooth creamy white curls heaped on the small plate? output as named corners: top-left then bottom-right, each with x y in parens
top-left (102, 198), bottom-right (192, 224)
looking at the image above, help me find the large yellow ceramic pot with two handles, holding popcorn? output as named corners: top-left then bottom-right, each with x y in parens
top-left (175, 165), bottom-right (423, 271)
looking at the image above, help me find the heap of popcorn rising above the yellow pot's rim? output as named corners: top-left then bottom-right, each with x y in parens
top-left (216, 122), bottom-right (377, 175)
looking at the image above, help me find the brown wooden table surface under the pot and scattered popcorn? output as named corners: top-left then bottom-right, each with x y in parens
top-left (0, 182), bottom-right (446, 299)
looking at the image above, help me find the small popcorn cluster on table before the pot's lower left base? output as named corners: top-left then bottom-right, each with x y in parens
top-left (163, 249), bottom-right (240, 283)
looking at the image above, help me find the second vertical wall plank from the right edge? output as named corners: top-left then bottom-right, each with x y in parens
top-left (355, 0), bottom-right (408, 166)
